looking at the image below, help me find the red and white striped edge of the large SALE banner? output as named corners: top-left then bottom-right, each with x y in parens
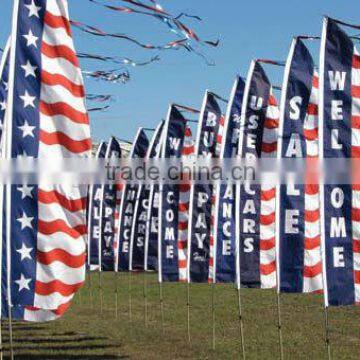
top-left (303, 71), bottom-right (323, 293)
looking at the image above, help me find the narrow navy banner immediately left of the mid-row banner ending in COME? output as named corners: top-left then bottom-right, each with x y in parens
top-left (144, 128), bottom-right (165, 271)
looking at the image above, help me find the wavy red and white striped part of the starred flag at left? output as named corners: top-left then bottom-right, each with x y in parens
top-left (34, 0), bottom-right (91, 311)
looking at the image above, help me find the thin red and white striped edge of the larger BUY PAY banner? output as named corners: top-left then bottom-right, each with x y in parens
top-left (208, 116), bottom-right (225, 283)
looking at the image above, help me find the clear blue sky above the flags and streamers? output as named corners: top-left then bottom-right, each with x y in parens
top-left (0, 0), bottom-right (360, 141)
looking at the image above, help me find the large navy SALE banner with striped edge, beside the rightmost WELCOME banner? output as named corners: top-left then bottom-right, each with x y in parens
top-left (276, 38), bottom-right (322, 293)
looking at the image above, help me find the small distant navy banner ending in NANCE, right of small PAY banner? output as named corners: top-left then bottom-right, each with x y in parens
top-left (115, 128), bottom-right (149, 271)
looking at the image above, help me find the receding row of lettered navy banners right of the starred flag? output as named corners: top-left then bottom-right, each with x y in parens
top-left (88, 18), bottom-right (360, 306)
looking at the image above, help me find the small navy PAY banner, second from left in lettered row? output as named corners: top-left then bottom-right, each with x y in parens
top-left (99, 137), bottom-right (121, 271)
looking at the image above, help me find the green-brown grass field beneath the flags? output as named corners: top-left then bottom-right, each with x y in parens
top-left (3, 273), bottom-right (360, 360)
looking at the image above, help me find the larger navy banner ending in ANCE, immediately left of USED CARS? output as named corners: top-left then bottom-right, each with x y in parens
top-left (210, 77), bottom-right (245, 282)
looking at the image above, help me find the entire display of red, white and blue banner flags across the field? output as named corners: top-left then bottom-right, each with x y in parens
top-left (0, 0), bottom-right (360, 321)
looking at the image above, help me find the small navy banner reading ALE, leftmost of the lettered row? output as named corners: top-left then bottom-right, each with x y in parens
top-left (87, 142), bottom-right (107, 271)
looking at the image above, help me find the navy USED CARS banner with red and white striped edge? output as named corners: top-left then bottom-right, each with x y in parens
top-left (236, 60), bottom-right (279, 288)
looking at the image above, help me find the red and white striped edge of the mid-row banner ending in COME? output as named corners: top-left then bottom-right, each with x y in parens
top-left (178, 126), bottom-right (195, 282)
